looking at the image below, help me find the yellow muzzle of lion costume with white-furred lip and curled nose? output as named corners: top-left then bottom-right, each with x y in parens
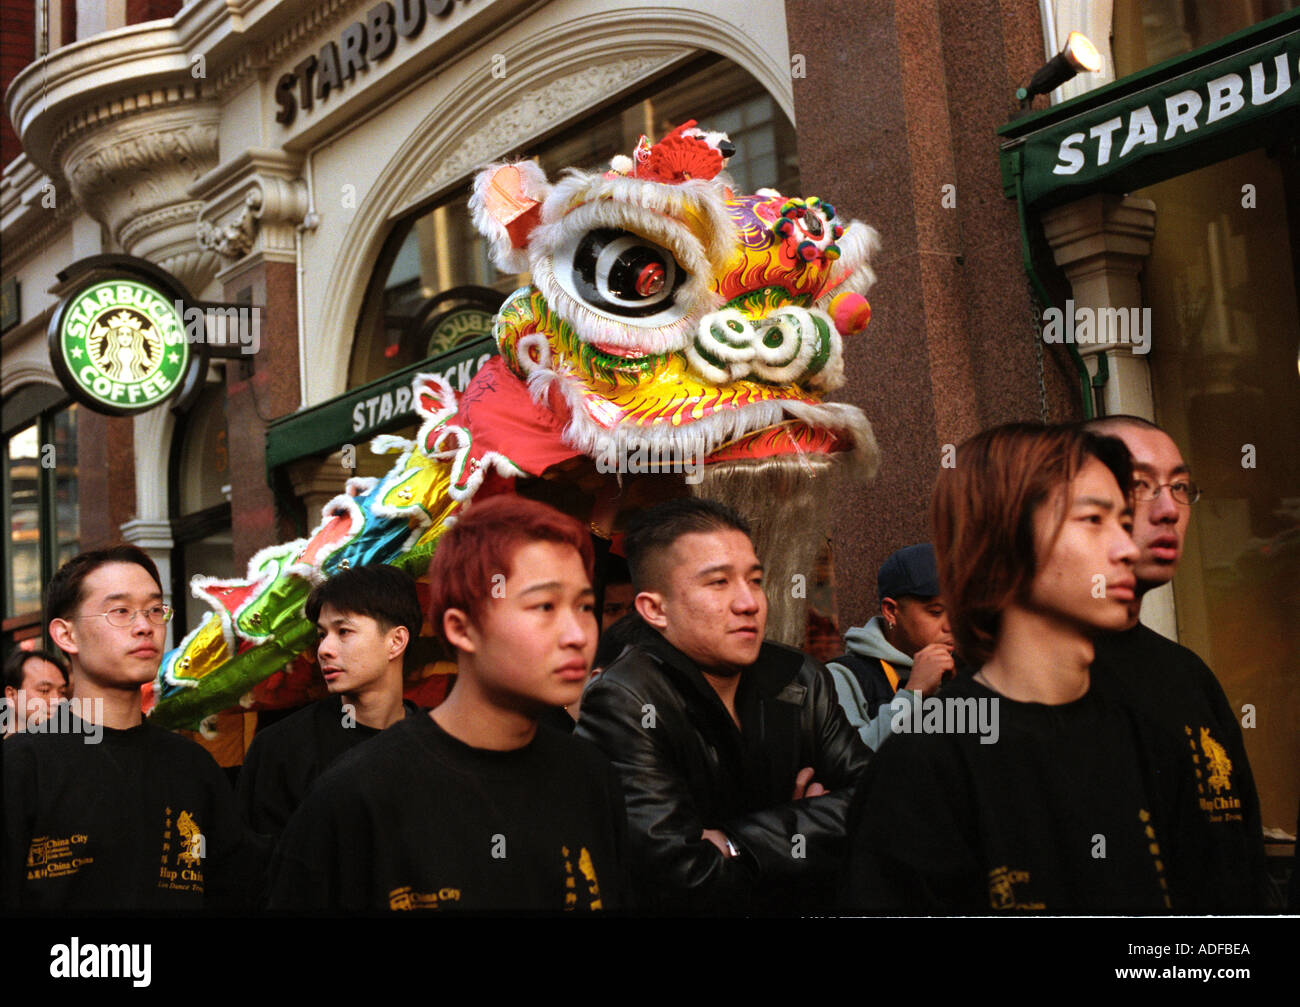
top-left (498, 278), bottom-right (875, 469)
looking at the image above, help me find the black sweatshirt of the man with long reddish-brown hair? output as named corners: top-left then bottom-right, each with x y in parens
top-left (846, 678), bottom-right (1169, 915)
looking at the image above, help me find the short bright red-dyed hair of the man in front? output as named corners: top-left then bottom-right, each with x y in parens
top-left (429, 494), bottom-right (599, 642)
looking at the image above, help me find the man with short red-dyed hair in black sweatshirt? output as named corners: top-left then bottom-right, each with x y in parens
top-left (270, 496), bottom-right (625, 912)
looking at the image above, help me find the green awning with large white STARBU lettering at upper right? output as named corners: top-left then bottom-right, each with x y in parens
top-left (998, 10), bottom-right (1300, 207)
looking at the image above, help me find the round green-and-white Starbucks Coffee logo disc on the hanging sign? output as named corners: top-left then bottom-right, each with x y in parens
top-left (57, 279), bottom-right (190, 412)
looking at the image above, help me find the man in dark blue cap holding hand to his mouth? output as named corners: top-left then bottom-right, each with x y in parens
top-left (827, 543), bottom-right (956, 750)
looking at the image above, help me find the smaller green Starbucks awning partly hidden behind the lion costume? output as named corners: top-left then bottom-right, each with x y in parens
top-left (267, 338), bottom-right (497, 473)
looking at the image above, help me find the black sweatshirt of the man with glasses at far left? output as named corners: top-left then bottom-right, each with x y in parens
top-left (4, 717), bottom-right (265, 912)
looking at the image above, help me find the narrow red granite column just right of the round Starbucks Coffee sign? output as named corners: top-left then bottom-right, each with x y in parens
top-left (222, 261), bottom-right (299, 568)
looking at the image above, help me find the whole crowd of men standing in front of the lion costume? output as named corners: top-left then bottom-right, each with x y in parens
top-left (3, 417), bottom-right (1271, 915)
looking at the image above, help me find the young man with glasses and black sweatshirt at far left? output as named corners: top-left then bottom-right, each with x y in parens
top-left (3, 546), bottom-right (260, 912)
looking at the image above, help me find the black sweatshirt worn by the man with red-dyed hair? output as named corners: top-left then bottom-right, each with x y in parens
top-left (270, 713), bottom-right (625, 912)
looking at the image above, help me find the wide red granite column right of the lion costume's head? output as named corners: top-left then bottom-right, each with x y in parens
top-left (785, 0), bottom-right (1079, 629)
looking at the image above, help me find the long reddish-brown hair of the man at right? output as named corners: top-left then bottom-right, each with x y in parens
top-left (931, 424), bottom-right (1132, 664)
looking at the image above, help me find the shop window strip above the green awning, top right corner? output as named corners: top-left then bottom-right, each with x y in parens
top-left (1112, 0), bottom-right (1295, 77)
